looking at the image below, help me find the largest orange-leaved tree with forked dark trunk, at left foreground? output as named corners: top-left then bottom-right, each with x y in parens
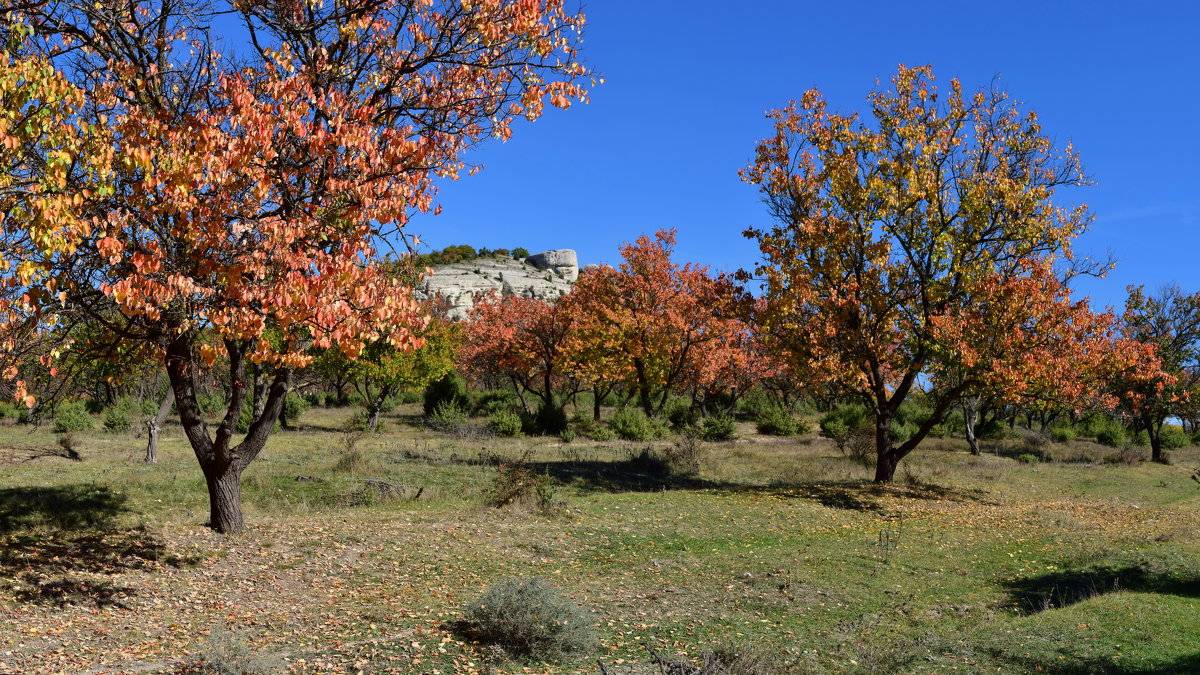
top-left (0, 0), bottom-right (588, 532)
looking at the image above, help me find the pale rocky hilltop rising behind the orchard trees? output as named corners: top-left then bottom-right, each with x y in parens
top-left (415, 249), bottom-right (580, 318)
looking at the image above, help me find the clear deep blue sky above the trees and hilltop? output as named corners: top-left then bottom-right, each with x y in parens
top-left (410, 0), bottom-right (1200, 305)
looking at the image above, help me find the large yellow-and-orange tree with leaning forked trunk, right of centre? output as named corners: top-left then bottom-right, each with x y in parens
top-left (742, 66), bottom-right (1118, 482)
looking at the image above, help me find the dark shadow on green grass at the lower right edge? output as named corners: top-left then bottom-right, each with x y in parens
top-left (1006, 562), bottom-right (1200, 614)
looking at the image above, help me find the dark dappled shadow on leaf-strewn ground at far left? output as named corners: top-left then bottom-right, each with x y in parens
top-left (0, 485), bottom-right (190, 608)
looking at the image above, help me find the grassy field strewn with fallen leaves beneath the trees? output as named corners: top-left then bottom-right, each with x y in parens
top-left (0, 406), bottom-right (1200, 674)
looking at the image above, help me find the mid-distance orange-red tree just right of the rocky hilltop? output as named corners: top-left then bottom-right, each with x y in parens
top-left (561, 229), bottom-right (737, 416)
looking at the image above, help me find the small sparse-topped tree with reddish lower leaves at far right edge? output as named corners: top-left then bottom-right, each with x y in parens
top-left (1112, 285), bottom-right (1200, 462)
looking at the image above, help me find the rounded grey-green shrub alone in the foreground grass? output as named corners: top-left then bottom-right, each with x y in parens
top-left (456, 578), bottom-right (599, 661)
